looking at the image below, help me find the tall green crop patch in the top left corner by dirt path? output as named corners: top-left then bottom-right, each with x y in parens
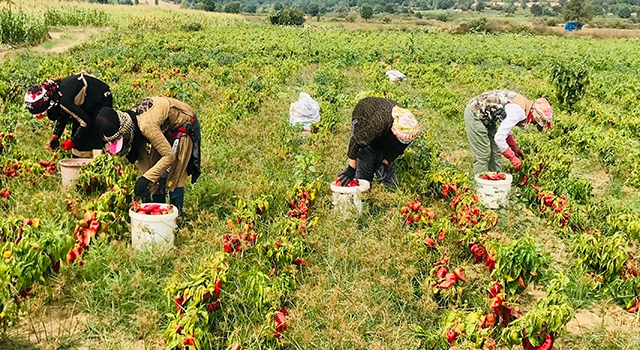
top-left (0, 8), bottom-right (49, 45)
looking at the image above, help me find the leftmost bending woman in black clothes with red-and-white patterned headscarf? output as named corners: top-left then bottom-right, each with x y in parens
top-left (24, 73), bottom-right (113, 158)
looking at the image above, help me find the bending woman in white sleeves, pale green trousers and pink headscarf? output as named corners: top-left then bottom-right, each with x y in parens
top-left (464, 90), bottom-right (553, 174)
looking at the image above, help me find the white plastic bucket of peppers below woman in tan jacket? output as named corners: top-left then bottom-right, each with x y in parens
top-left (129, 203), bottom-right (178, 249)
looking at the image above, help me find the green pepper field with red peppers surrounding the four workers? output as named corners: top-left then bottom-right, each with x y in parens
top-left (0, 4), bottom-right (640, 350)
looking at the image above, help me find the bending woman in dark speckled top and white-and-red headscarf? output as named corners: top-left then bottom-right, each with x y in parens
top-left (338, 97), bottom-right (420, 186)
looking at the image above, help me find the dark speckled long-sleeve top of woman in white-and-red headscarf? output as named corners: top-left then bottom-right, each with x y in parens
top-left (347, 97), bottom-right (408, 162)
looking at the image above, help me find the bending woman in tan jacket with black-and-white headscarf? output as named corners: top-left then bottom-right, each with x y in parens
top-left (96, 97), bottom-right (200, 211)
